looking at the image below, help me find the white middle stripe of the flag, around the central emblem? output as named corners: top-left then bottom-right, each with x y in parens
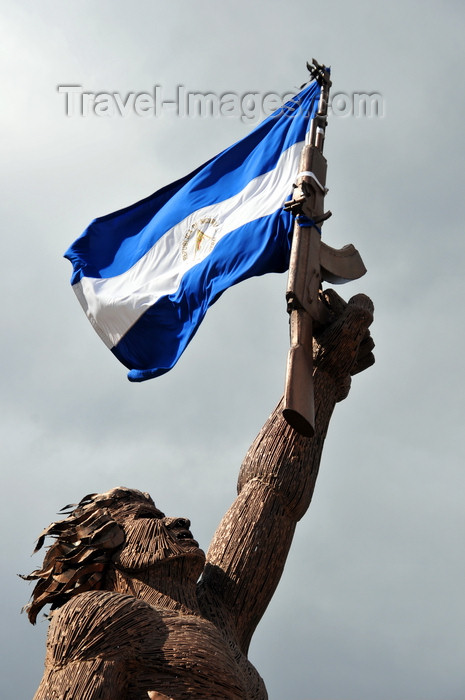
top-left (73, 141), bottom-right (303, 348)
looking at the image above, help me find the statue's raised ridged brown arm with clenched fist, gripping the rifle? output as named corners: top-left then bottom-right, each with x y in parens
top-left (201, 290), bottom-right (374, 653)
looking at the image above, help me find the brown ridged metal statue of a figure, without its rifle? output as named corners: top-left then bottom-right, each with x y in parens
top-left (26, 291), bottom-right (373, 700)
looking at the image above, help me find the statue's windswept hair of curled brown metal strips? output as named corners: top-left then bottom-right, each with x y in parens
top-left (22, 487), bottom-right (154, 624)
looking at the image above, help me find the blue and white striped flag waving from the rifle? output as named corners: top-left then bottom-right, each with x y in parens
top-left (65, 82), bottom-right (320, 381)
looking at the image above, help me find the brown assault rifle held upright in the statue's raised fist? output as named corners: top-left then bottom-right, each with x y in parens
top-left (283, 59), bottom-right (366, 437)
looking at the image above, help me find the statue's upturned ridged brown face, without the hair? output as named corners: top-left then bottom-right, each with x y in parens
top-left (112, 500), bottom-right (205, 571)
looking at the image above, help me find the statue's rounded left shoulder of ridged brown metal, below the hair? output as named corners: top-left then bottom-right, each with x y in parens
top-left (47, 591), bottom-right (157, 666)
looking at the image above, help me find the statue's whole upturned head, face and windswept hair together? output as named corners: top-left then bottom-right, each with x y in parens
top-left (23, 487), bottom-right (205, 624)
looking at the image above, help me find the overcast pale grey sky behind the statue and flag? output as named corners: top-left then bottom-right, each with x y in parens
top-left (0, 0), bottom-right (465, 700)
